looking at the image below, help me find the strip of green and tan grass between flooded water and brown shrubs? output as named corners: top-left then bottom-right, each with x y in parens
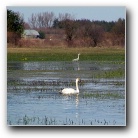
top-left (7, 47), bottom-right (125, 61)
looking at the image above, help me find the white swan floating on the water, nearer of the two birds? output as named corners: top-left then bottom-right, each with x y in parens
top-left (60, 78), bottom-right (80, 94)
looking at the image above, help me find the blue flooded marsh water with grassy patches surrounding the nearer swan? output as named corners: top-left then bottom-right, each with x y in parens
top-left (7, 61), bottom-right (126, 126)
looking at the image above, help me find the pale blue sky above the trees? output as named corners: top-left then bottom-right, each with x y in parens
top-left (7, 6), bottom-right (126, 22)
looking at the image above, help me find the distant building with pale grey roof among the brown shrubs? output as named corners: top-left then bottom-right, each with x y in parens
top-left (22, 29), bottom-right (39, 38)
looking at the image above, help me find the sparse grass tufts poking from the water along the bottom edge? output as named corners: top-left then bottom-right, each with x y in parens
top-left (7, 115), bottom-right (116, 126)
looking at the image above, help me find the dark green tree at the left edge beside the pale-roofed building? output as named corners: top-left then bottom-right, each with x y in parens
top-left (7, 10), bottom-right (24, 45)
